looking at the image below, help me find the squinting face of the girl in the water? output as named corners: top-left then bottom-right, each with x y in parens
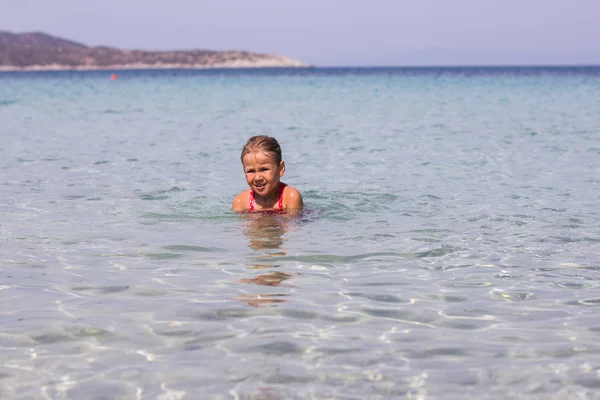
top-left (242, 151), bottom-right (285, 197)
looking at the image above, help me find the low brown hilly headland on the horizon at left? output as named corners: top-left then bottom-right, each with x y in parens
top-left (0, 31), bottom-right (308, 70)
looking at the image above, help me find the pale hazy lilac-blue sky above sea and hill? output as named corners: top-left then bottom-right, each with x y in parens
top-left (0, 0), bottom-right (600, 66)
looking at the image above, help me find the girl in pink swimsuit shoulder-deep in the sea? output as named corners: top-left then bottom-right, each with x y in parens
top-left (231, 135), bottom-right (304, 212)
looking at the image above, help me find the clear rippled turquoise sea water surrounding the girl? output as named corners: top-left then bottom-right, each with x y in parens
top-left (0, 68), bottom-right (600, 399)
